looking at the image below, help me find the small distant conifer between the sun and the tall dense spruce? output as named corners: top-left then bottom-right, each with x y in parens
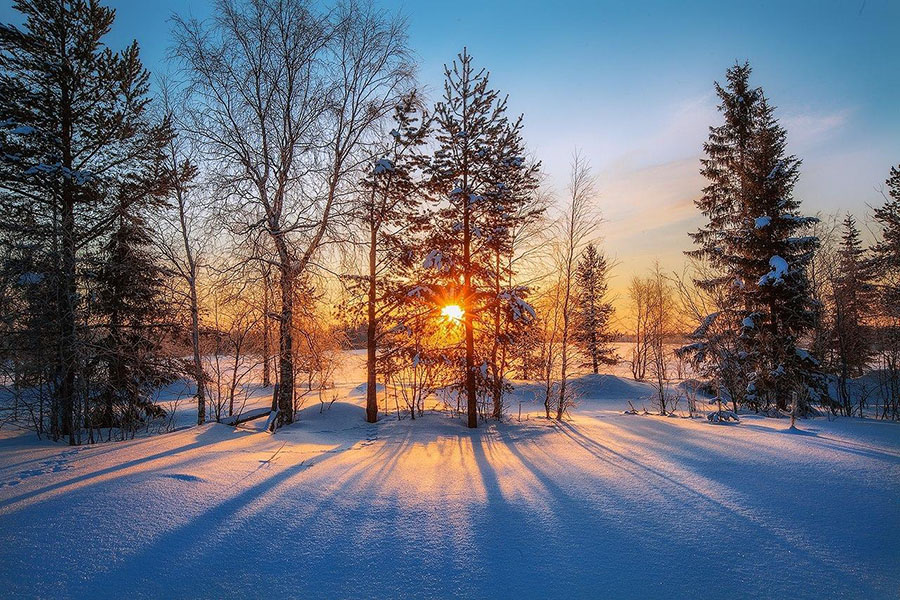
top-left (575, 244), bottom-right (617, 374)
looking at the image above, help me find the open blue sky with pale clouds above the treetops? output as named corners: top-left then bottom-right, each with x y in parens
top-left (0, 0), bottom-right (900, 296)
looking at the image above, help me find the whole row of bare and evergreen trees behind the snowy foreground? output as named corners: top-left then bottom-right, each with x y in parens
top-left (0, 0), bottom-right (900, 444)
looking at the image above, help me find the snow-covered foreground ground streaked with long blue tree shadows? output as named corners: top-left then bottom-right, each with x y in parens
top-left (0, 354), bottom-right (900, 598)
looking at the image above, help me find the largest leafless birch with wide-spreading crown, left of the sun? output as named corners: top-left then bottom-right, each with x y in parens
top-left (175, 0), bottom-right (410, 432)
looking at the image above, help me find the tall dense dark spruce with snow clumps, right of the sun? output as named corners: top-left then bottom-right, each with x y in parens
top-left (688, 63), bottom-right (823, 409)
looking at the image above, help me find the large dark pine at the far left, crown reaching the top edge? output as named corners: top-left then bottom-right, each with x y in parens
top-left (0, 0), bottom-right (170, 444)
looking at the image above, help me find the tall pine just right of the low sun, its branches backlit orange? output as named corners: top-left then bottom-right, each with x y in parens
top-left (425, 50), bottom-right (537, 427)
